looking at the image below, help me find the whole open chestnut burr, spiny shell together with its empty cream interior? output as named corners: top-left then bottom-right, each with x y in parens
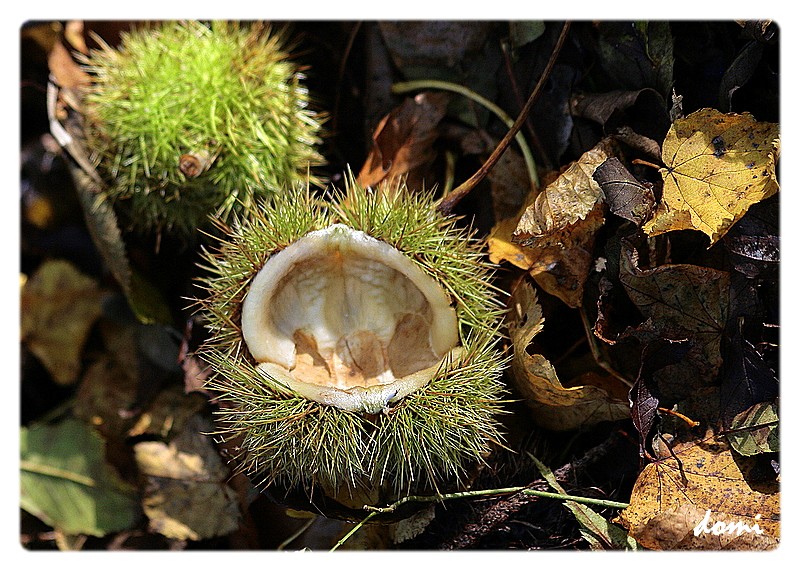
top-left (195, 180), bottom-right (506, 507)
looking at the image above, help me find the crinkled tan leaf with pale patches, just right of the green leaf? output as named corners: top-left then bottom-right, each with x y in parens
top-left (134, 416), bottom-right (239, 541)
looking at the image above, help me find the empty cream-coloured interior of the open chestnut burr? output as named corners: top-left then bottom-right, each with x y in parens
top-left (242, 224), bottom-right (458, 412)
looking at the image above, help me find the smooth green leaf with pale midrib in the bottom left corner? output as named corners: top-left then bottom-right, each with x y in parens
top-left (20, 419), bottom-right (139, 537)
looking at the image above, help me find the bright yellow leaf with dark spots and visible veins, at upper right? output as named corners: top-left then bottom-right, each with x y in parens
top-left (644, 109), bottom-right (780, 244)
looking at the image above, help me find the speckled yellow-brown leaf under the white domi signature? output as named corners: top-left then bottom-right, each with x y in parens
top-left (619, 437), bottom-right (780, 550)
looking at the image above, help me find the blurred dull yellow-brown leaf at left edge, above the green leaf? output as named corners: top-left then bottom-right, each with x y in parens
top-left (20, 260), bottom-right (104, 384)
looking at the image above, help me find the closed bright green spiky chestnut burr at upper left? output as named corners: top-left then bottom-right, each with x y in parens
top-left (78, 21), bottom-right (323, 234)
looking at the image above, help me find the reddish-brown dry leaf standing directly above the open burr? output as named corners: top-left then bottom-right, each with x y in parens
top-left (357, 92), bottom-right (449, 190)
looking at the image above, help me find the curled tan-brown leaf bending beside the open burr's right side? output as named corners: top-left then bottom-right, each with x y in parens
top-left (508, 283), bottom-right (630, 430)
